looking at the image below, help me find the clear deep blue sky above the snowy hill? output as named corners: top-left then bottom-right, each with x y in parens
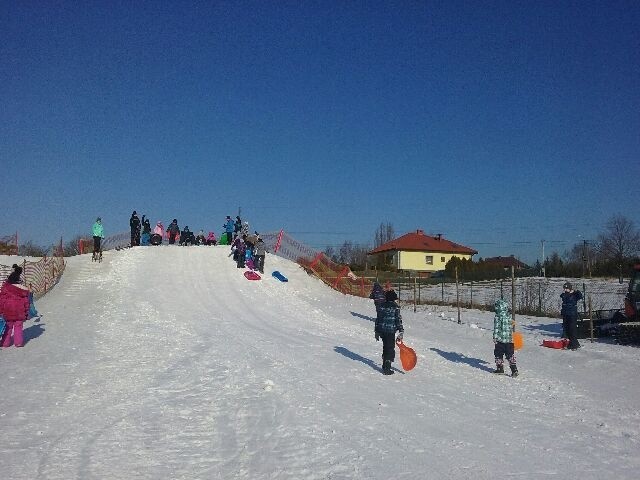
top-left (0, 1), bottom-right (640, 262)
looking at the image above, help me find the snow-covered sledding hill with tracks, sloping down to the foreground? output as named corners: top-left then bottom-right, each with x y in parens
top-left (0, 246), bottom-right (640, 480)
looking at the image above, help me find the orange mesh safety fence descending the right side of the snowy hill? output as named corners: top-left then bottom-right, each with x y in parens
top-left (260, 230), bottom-right (373, 298)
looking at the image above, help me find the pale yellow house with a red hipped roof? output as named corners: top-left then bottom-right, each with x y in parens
top-left (367, 230), bottom-right (478, 272)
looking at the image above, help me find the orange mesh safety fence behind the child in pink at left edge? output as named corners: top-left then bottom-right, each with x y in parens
top-left (0, 240), bottom-right (66, 298)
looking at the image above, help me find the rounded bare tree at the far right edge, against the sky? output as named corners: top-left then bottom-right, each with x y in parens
top-left (598, 215), bottom-right (640, 280)
